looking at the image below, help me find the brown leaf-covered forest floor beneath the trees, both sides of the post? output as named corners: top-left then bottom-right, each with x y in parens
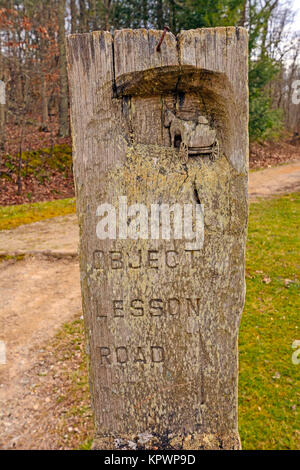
top-left (0, 123), bottom-right (300, 205)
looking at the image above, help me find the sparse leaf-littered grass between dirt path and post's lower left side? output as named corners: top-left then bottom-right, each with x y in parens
top-left (30, 312), bottom-right (94, 450)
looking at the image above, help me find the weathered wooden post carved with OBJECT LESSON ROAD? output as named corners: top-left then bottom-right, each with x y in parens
top-left (67, 27), bottom-right (248, 449)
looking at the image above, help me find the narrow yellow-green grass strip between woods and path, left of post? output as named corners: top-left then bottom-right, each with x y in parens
top-left (0, 198), bottom-right (76, 230)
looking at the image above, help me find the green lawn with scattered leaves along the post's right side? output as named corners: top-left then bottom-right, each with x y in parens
top-left (239, 194), bottom-right (300, 449)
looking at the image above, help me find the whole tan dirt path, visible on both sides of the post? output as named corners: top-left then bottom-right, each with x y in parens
top-left (0, 162), bottom-right (300, 449)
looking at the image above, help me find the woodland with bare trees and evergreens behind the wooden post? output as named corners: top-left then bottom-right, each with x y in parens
top-left (0, 0), bottom-right (300, 205)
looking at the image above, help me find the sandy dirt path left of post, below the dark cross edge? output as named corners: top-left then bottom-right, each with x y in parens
top-left (0, 257), bottom-right (81, 448)
